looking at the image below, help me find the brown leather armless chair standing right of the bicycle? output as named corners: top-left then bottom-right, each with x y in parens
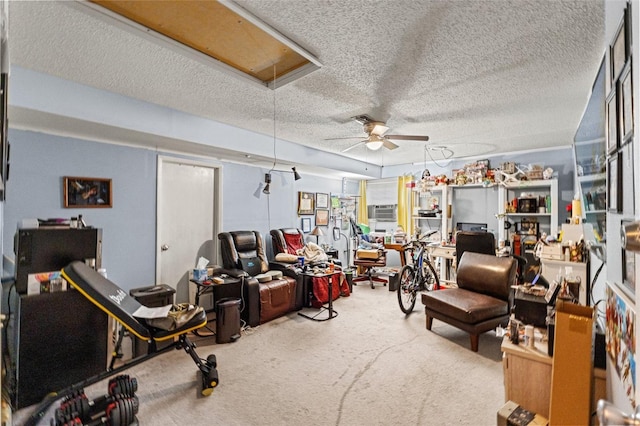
top-left (422, 251), bottom-right (517, 352)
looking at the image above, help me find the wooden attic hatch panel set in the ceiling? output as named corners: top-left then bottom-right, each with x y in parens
top-left (91, 0), bottom-right (310, 83)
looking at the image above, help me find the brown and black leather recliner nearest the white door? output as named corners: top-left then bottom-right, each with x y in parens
top-left (218, 231), bottom-right (302, 327)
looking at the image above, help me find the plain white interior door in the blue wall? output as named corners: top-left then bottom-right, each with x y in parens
top-left (156, 157), bottom-right (222, 303)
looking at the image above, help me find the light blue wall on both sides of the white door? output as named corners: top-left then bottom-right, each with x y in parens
top-left (3, 130), bottom-right (350, 290)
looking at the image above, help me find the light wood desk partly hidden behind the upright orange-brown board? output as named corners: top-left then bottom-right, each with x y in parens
top-left (501, 330), bottom-right (607, 418)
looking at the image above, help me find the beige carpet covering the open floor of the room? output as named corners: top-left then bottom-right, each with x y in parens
top-left (14, 285), bottom-right (504, 426)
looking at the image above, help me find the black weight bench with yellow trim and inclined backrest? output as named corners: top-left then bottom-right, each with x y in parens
top-left (27, 261), bottom-right (218, 425)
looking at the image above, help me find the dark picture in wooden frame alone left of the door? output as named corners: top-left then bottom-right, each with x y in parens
top-left (63, 176), bottom-right (113, 208)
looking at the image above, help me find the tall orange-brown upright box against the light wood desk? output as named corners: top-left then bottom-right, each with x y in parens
top-left (549, 300), bottom-right (595, 425)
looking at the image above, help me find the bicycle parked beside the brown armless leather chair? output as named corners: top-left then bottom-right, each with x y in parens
top-left (398, 231), bottom-right (440, 315)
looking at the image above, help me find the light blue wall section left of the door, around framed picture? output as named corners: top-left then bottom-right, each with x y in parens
top-left (3, 131), bottom-right (156, 288)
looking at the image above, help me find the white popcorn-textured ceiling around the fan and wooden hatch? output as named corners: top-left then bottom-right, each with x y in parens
top-left (9, 0), bottom-right (605, 170)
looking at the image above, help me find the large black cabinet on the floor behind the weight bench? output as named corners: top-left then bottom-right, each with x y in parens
top-left (3, 290), bottom-right (108, 409)
